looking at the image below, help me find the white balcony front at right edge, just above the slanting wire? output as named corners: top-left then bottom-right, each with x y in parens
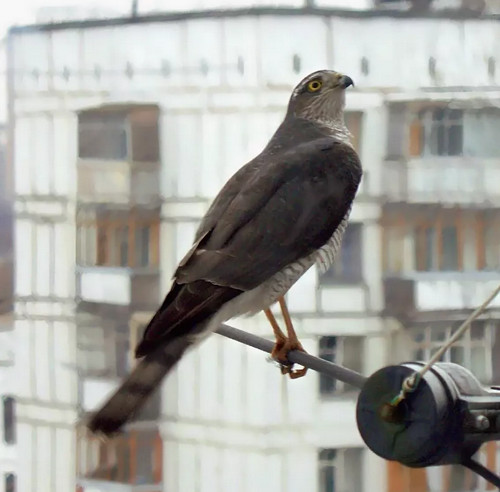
top-left (384, 272), bottom-right (500, 317)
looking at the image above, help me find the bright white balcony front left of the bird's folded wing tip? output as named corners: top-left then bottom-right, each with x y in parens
top-left (77, 266), bottom-right (160, 310)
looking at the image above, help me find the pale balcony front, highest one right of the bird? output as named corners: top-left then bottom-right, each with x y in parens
top-left (382, 157), bottom-right (500, 207)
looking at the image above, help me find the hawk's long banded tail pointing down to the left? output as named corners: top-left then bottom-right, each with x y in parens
top-left (87, 335), bottom-right (196, 436)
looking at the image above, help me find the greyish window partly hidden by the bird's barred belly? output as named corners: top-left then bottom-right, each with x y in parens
top-left (320, 223), bottom-right (363, 284)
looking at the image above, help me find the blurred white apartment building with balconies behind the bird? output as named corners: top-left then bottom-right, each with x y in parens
top-left (0, 0), bottom-right (500, 492)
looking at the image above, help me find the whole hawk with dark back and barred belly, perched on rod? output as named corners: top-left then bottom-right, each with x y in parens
top-left (87, 70), bottom-right (362, 435)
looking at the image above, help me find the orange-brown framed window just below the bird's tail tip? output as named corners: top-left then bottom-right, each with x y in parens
top-left (78, 429), bottom-right (163, 485)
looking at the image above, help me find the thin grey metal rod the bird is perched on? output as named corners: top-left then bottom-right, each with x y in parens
top-left (216, 325), bottom-right (366, 389)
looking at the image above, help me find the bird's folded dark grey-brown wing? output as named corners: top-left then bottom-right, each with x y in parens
top-left (137, 138), bottom-right (361, 355)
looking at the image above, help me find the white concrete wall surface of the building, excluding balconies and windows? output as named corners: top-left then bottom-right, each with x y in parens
top-left (8, 9), bottom-right (500, 492)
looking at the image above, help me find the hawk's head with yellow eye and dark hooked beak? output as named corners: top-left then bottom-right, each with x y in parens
top-left (287, 70), bottom-right (354, 125)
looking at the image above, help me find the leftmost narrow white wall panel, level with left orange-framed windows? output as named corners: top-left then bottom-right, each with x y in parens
top-left (14, 219), bottom-right (34, 296)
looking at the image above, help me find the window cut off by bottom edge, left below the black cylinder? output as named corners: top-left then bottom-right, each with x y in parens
top-left (318, 448), bottom-right (363, 492)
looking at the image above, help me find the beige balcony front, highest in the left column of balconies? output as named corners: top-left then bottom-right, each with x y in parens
top-left (78, 159), bottom-right (160, 205)
